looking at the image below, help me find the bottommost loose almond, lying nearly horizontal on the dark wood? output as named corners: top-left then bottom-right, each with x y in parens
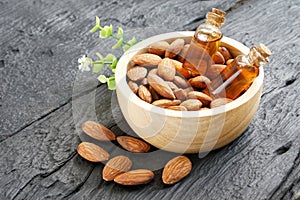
top-left (114, 169), bottom-right (154, 185)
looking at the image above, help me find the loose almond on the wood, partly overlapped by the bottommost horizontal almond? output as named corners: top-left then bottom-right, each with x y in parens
top-left (102, 156), bottom-right (132, 181)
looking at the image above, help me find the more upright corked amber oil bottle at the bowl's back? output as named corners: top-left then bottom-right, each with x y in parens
top-left (183, 8), bottom-right (226, 75)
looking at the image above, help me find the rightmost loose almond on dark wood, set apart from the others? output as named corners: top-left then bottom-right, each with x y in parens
top-left (162, 156), bottom-right (192, 184)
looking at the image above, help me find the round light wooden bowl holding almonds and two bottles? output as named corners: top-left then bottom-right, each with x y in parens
top-left (115, 31), bottom-right (264, 153)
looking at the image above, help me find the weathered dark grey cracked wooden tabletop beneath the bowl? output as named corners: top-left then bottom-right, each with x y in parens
top-left (0, 0), bottom-right (300, 200)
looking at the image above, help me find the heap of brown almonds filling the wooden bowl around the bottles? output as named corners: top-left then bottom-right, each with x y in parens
top-left (127, 39), bottom-right (233, 111)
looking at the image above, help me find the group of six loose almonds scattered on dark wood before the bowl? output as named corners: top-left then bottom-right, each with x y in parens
top-left (77, 121), bottom-right (192, 185)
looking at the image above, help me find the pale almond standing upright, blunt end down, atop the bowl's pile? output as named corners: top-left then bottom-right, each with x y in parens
top-left (157, 58), bottom-right (176, 81)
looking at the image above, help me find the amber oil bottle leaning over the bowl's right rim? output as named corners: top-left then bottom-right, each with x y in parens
top-left (208, 44), bottom-right (271, 99)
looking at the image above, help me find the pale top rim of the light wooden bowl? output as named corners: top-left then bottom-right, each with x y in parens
top-left (115, 31), bottom-right (264, 118)
